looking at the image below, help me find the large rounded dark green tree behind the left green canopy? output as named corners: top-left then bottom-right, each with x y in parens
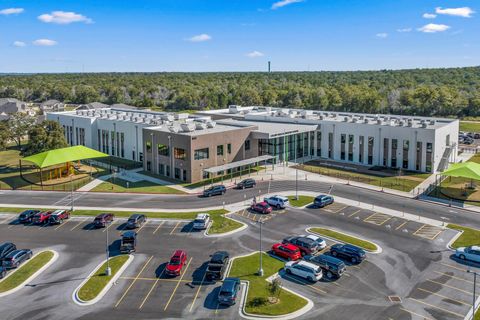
top-left (22, 120), bottom-right (67, 156)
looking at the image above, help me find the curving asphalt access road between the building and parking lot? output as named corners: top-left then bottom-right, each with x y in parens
top-left (0, 180), bottom-right (480, 228)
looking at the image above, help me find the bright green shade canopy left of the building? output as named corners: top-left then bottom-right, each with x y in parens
top-left (22, 146), bottom-right (108, 168)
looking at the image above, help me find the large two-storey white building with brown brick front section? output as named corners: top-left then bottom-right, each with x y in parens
top-left (47, 106), bottom-right (459, 182)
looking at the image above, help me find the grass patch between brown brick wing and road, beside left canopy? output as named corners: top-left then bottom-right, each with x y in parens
top-left (91, 178), bottom-right (184, 194)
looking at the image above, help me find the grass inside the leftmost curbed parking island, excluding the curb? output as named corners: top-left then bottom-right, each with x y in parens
top-left (0, 251), bottom-right (53, 292)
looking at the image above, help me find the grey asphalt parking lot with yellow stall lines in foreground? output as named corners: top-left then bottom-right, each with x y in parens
top-left (0, 203), bottom-right (477, 320)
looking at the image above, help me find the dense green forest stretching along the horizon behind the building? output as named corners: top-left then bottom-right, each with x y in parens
top-left (0, 67), bottom-right (480, 117)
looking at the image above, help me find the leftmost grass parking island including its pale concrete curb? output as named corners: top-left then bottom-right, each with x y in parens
top-left (0, 250), bottom-right (58, 297)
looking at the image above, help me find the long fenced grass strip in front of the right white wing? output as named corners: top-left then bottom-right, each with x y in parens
top-left (298, 165), bottom-right (430, 192)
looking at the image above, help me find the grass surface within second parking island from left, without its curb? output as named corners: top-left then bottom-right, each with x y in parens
top-left (78, 255), bottom-right (129, 302)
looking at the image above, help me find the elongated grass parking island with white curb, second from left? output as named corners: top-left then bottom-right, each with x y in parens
top-left (73, 255), bottom-right (133, 305)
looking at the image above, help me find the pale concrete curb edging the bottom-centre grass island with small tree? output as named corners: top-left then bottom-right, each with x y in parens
top-left (225, 251), bottom-right (314, 320)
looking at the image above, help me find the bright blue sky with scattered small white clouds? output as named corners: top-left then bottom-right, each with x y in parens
top-left (0, 0), bottom-right (480, 72)
